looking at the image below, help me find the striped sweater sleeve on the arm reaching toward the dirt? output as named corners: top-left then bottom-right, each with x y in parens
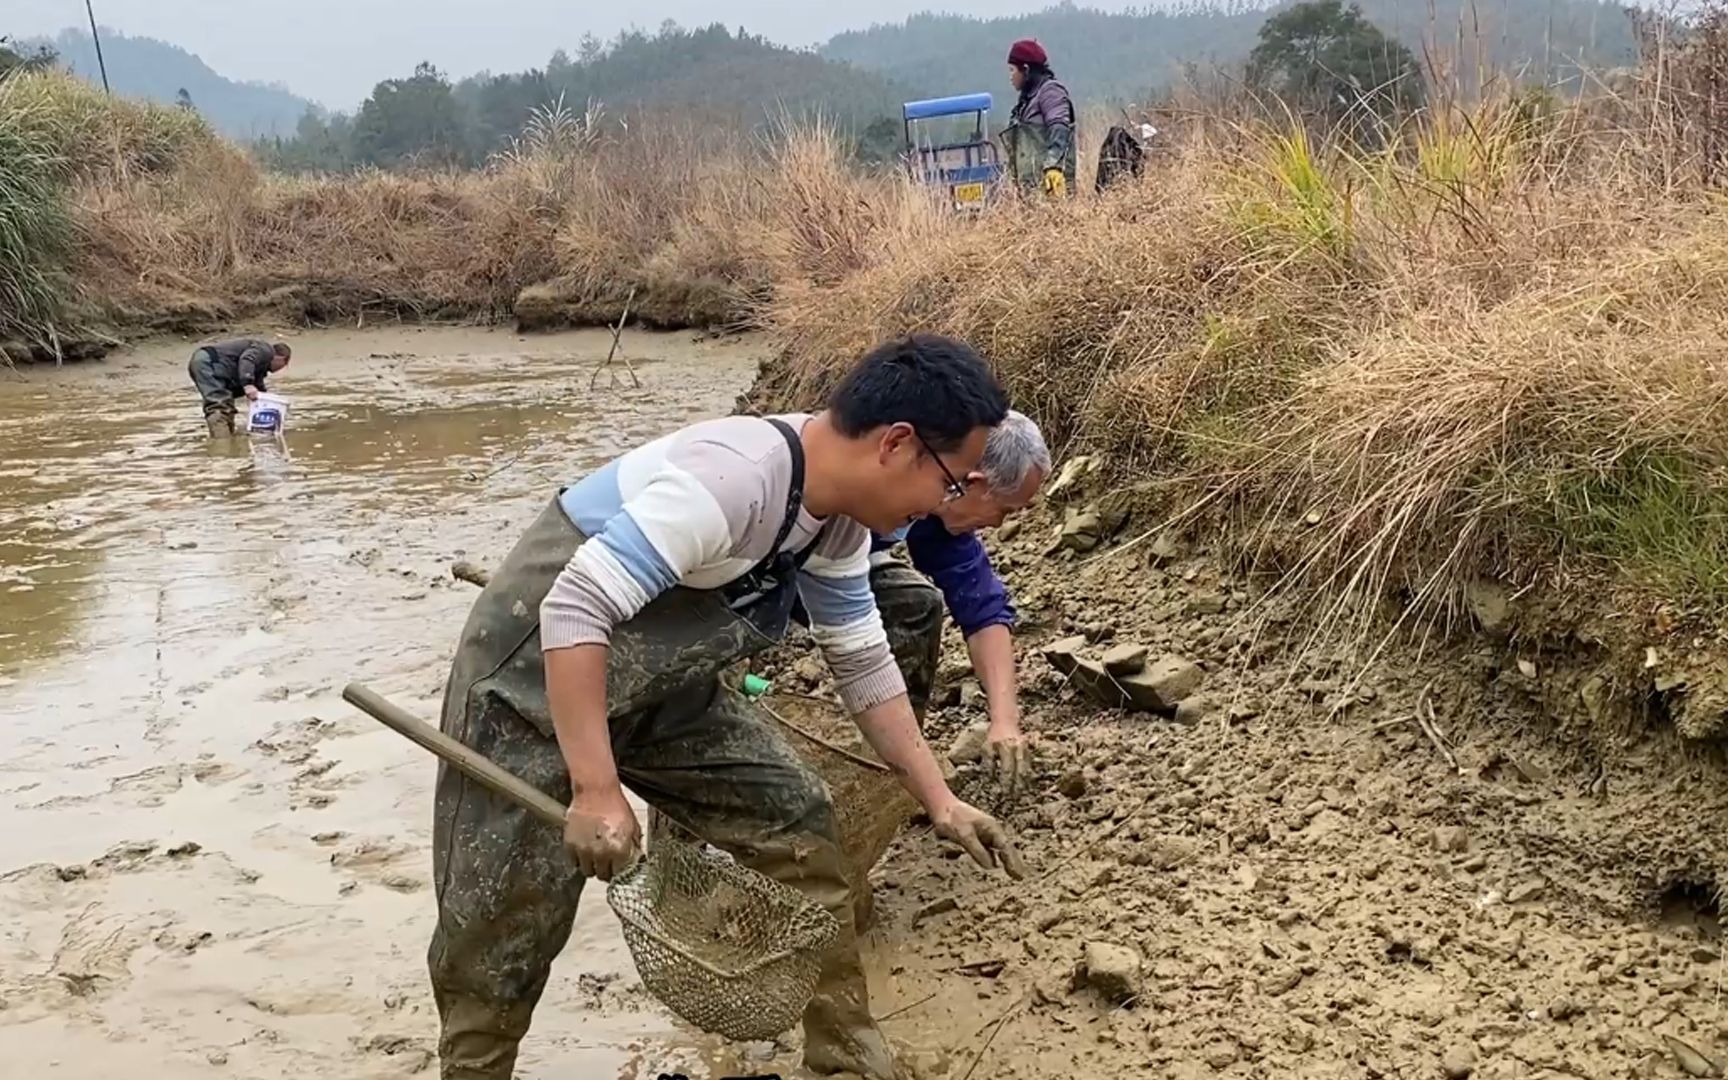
top-left (798, 520), bottom-right (905, 715)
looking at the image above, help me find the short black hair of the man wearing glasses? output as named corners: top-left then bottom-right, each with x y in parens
top-left (828, 334), bottom-right (1007, 453)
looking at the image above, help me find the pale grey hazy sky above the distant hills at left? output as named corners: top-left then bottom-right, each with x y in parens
top-left (10, 0), bottom-right (1128, 109)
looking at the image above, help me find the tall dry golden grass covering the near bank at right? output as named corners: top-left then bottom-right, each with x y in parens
top-left (764, 98), bottom-right (1728, 667)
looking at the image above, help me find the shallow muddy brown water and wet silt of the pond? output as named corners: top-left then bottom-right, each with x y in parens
top-left (0, 330), bottom-right (755, 1080)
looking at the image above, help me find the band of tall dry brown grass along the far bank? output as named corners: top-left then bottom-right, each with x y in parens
top-left (0, 88), bottom-right (891, 346)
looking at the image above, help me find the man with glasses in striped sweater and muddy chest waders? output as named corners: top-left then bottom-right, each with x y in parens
top-left (429, 337), bottom-right (1020, 1080)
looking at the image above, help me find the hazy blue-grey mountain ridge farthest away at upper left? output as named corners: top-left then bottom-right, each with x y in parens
top-left (21, 28), bottom-right (314, 140)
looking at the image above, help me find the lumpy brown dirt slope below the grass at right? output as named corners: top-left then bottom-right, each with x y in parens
top-left (725, 463), bottom-right (1728, 1080)
